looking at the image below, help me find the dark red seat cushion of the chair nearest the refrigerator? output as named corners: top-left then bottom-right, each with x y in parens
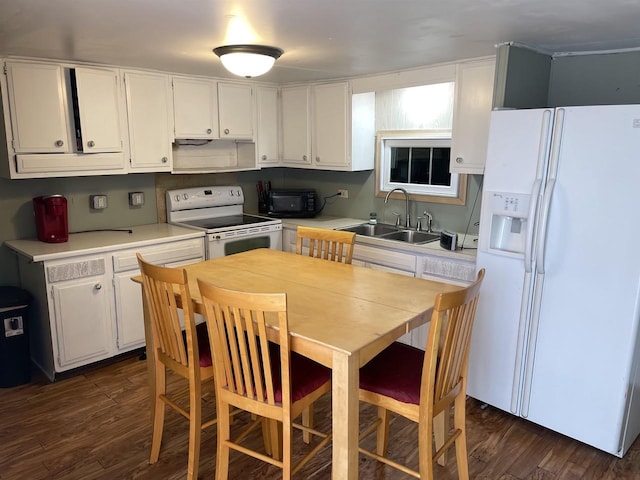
top-left (360, 342), bottom-right (424, 405)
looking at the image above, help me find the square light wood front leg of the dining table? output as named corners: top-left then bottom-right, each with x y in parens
top-left (331, 352), bottom-right (360, 480)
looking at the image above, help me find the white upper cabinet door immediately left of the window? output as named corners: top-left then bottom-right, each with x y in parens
top-left (311, 82), bottom-right (351, 168)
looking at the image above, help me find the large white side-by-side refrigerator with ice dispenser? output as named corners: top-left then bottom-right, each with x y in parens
top-left (467, 105), bottom-right (640, 457)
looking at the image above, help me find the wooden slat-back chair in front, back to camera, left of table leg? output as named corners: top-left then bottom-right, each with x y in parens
top-left (198, 279), bottom-right (331, 480)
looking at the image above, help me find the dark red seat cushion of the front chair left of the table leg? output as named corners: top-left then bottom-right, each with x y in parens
top-left (269, 343), bottom-right (331, 402)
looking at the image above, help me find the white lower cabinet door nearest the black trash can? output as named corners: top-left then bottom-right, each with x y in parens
top-left (51, 275), bottom-right (113, 369)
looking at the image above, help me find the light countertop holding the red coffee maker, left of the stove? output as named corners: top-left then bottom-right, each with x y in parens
top-left (5, 223), bottom-right (204, 262)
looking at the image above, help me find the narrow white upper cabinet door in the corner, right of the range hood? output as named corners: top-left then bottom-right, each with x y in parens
top-left (256, 87), bottom-right (278, 167)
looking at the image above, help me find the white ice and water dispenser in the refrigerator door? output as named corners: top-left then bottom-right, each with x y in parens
top-left (484, 192), bottom-right (531, 254)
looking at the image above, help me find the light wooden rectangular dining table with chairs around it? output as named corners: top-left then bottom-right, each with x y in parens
top-left (134, 249), bottom-right (459, 480)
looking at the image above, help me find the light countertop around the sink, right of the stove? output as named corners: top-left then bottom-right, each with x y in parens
top-left (282, 215), bottom-right (478, 262)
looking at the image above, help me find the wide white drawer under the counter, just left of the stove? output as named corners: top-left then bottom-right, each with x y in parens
top-left (113, 238), bottom-right (204, 273)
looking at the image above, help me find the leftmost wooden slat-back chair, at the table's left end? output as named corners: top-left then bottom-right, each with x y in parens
top-left (137, 254), bottom-right (216, 480)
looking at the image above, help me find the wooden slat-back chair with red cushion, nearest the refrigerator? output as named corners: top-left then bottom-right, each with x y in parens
top-left (360, 269), bottom-right (484, 480)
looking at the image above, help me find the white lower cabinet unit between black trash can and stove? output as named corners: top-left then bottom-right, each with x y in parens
top-left (18, 237), bottom-right (204, 380)
